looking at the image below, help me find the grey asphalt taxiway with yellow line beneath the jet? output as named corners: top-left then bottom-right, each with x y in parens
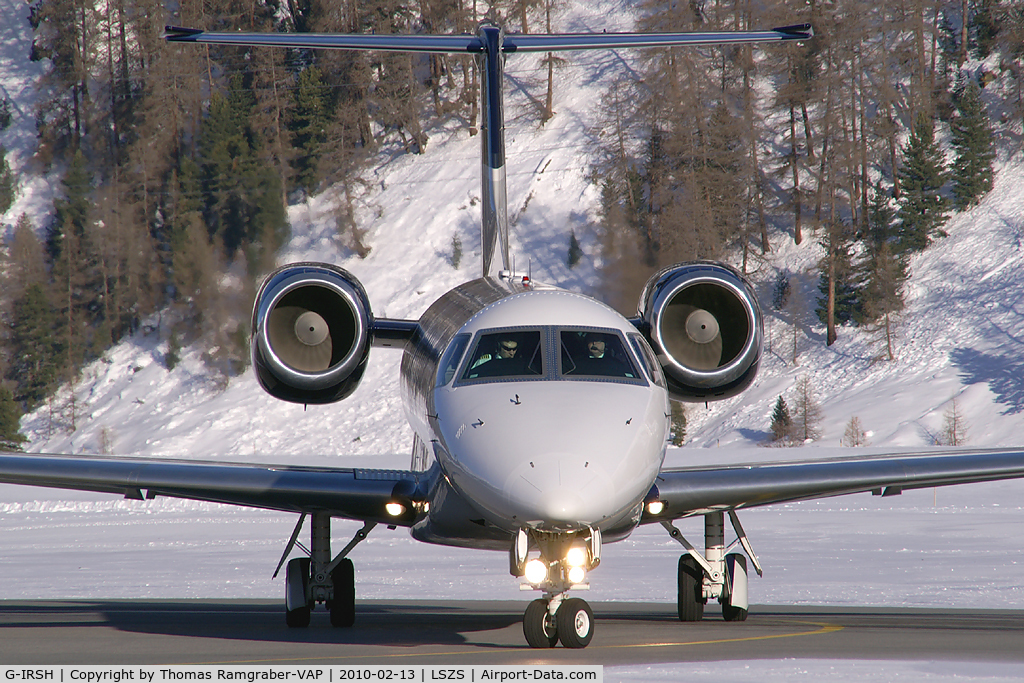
top-left (0, 600), bottom-right (1024, 666)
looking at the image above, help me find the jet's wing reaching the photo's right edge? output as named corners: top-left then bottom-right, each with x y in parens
top-left (643, 449), bottom-right (1024, 522)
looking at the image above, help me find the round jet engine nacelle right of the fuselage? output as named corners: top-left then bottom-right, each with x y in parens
top-left (638, 261), bottom-right (764, 401)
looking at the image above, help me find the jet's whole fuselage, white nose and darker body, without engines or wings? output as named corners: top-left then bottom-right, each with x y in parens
top-left (402, 279), bottom-right (670, 548)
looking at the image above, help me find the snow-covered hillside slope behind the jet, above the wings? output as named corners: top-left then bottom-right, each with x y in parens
top-left (6, 0), bottom-right (1024, 458)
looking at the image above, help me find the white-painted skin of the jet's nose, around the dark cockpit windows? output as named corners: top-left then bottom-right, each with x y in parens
top-left (414, 289), bottom-right (670, 532)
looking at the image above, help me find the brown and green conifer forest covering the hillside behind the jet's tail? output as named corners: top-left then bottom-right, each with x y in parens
top-left (0, 0), bottom-right (1024, 446)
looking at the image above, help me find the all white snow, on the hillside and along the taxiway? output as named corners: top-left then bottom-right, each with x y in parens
top-left (0, 0), bottom-right (1024, 681)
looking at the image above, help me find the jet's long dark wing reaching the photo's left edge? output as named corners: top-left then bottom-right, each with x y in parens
top-left (0, 454), bottom-right (430, 526)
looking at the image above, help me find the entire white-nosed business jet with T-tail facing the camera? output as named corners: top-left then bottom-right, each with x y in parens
top-left (0, 24), bottom-right (1024, 648)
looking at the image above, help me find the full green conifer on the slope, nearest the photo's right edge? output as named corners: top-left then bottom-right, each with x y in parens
top-left (949, 81), bottom-right (995, 211)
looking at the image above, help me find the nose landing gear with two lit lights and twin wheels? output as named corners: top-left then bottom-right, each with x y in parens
top-left (509, 528), bottom-right (601, 649)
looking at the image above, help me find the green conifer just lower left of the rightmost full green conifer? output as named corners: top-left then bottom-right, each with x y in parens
top-left (896, 114), bottom-right (949, 251)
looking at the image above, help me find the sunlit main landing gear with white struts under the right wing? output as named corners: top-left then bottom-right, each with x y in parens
top-left (662, 510), bottom-right (763, 622)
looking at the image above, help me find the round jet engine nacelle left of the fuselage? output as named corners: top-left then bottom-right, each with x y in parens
top-left (250, 263), bottom-right (373, 403)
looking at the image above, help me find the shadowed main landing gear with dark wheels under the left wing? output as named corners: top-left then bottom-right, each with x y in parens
top-left (273, 512), bottom-right (377, 628)
